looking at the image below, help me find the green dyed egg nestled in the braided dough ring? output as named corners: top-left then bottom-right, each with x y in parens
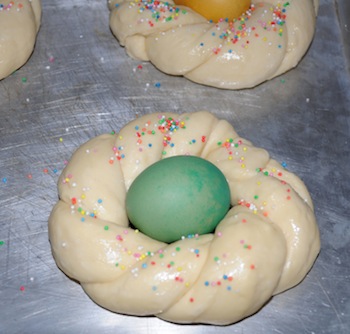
top-left (126, 156), bottom-right (230, 243)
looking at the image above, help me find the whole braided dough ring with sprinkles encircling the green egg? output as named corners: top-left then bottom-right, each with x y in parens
top-left (49, 112), bottom-right (320, 325)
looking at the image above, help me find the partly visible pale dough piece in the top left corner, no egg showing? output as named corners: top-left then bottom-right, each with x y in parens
top-left (0, 0), bottom-right (41, 80)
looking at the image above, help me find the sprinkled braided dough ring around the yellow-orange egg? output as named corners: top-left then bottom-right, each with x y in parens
top-left (109, 0), bottom-right (318, 89)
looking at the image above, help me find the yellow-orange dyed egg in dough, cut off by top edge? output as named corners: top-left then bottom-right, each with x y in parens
top-left (174, 0), bottom-right (251, 22)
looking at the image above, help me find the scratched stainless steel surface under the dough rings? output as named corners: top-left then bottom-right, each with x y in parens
top-left (0, 0), bottom-right (350, 334)
